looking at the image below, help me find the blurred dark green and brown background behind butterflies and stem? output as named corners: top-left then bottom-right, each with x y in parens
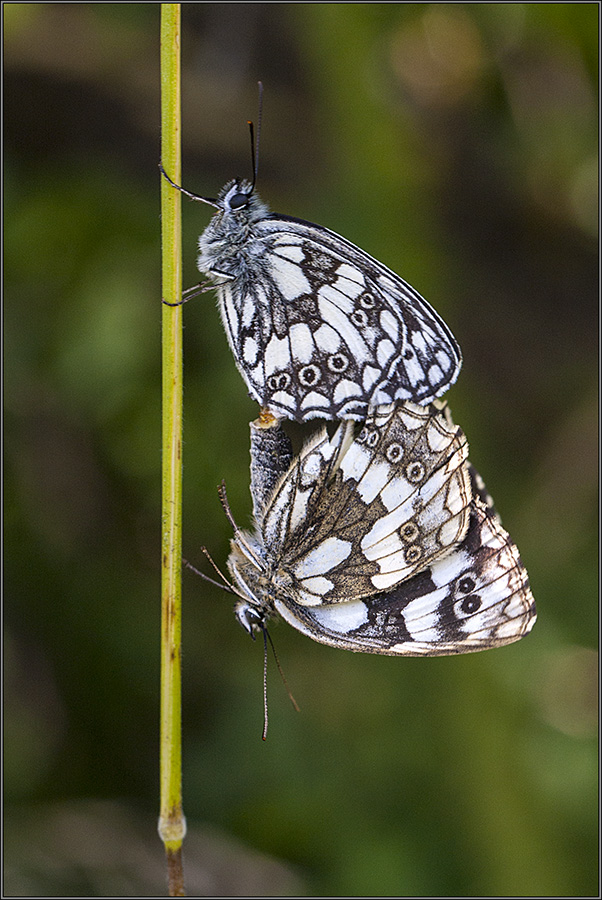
top-left (3, 3), bottom-right (598, 896)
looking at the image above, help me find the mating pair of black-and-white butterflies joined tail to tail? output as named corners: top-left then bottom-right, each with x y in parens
top-left (164, 156), bottom-right (535, 655)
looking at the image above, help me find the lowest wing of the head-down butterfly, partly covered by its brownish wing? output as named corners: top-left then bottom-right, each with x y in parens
top-left (275, 498), bottom-right (536, 656)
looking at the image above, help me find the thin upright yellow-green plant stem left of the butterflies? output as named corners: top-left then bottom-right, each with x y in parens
top-left (159, 3), bottom-right (186, 897)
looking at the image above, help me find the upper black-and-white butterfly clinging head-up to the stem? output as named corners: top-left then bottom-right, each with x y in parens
top-left (162, 170), bottom-right (462, 422)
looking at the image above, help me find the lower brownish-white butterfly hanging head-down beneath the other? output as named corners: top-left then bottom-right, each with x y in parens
top-left (223, 402), bottom-right (536, 656)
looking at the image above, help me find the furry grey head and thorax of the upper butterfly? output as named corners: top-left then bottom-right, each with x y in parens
top-left (197, 179), bottom-right (269, 279)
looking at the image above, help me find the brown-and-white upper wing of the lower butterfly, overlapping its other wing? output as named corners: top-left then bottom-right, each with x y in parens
top-left (276, 403), bottom-right (472, 606)
